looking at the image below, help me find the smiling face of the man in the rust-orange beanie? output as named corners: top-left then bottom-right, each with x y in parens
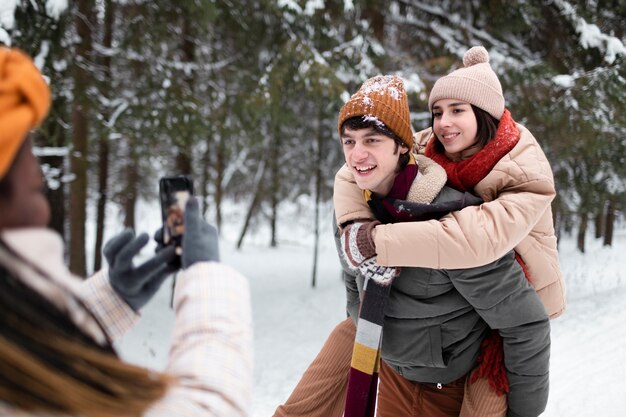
top-left (341, 127), bottom-right (408, 197)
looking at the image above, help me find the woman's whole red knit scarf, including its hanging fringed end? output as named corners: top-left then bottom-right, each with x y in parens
top-left (425, 110), bottom-right (530, 395)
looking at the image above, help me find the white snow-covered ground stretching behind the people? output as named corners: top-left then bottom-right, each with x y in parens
top-left (113, 201), bottom-right (626, 417)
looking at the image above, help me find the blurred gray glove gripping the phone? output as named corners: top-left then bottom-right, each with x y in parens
top-left (182, 198), bottom-right (220, 269)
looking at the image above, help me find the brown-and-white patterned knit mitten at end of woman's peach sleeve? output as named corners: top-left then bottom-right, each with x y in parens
top-left (341, 221), bottom-right (380, 271)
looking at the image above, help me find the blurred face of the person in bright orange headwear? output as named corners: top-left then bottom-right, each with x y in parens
top-left (0, 139), bottom-right (50, 230)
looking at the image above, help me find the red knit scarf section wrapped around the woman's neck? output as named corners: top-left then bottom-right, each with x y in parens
top-left (425, 110), bottom-right (520, 191)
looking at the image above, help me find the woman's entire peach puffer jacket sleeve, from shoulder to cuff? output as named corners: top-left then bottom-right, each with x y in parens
top-left (374, 133), bottom-right (556, 269)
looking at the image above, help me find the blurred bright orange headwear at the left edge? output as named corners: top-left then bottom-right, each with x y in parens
top-left (0, 47), bottom-right (50, 179)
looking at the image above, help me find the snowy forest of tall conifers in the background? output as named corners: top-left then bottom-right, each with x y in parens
top-left (0, 0), bottom-right (626, 274)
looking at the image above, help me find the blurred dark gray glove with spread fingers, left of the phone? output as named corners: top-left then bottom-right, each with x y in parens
top-left (102, 229), bottom-right (176, 311)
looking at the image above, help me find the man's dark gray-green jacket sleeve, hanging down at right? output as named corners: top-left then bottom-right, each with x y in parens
top-left (448, 252), bottom-right (550, 417)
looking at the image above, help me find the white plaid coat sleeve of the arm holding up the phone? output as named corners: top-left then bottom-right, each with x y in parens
top-left (145, 262), bottom-right (253, 417)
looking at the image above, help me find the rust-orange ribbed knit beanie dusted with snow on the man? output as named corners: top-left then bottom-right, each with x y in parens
top-left (338, 75), bottom-right (413, 149)
